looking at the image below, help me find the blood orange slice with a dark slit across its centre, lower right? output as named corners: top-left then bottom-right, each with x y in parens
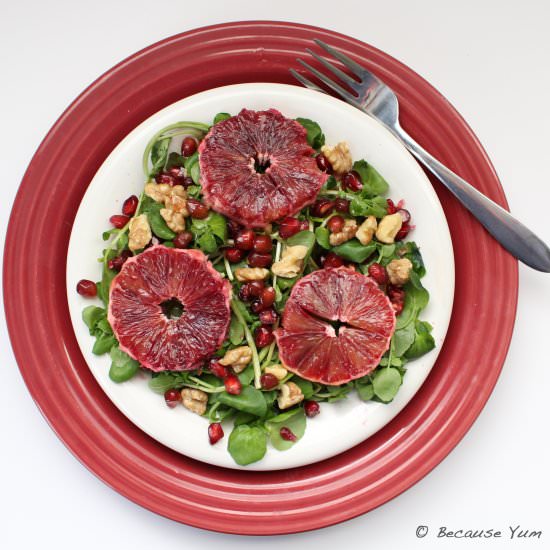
top-left (275, 267), bottom-right (395, 385)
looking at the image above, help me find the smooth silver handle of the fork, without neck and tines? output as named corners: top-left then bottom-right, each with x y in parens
top-left (394, 127), bottom-right (550, 273)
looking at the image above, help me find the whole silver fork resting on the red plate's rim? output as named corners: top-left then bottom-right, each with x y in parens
top-left (290, 40), bottom-right (550, 273)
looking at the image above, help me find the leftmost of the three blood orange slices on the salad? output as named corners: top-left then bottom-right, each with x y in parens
top-left (109, 246), bottom-right (231, 371)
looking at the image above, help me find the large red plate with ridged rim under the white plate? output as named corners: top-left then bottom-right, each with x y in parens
top-left (4, 22), bottom-right (518, 534)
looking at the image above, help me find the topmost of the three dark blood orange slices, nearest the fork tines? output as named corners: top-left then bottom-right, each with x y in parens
top-left (199, 109), bottom-right (328, 227)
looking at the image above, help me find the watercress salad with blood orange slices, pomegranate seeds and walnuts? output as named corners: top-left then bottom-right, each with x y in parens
top-left (77, 109), bottom-right (435, 465)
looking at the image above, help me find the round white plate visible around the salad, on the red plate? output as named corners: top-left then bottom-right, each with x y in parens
top-left (67, 83), bottom-right (454, 470)
